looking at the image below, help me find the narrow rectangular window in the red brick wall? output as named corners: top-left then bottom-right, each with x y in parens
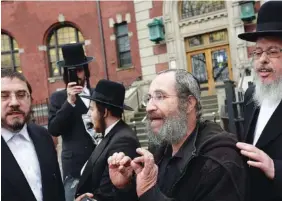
top-left (115, 22), bottom-right (132, 68)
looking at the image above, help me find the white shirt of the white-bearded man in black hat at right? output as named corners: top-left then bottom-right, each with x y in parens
top-left (253, 99), bottom-right (281, 145)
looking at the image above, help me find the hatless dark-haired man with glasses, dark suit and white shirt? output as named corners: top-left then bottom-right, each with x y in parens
top-left (1, 69), bottom-right (65, 201)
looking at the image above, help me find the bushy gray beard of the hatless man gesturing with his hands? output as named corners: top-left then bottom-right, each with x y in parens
top-left (147, 109), bottom-right (188, 146)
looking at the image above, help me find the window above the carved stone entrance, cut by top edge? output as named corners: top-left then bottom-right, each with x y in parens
top-left (180, 0), bottom-right (225, 19)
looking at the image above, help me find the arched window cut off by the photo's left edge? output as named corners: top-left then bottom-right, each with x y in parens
top-left (1, 33), bottom-right (22, 73)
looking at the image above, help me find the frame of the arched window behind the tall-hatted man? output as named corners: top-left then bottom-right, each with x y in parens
top-left (46, 24), bottom-right (85, 78)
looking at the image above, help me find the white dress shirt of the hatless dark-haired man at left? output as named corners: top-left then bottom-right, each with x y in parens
top-left (1, 124), bottom-right (43, 201)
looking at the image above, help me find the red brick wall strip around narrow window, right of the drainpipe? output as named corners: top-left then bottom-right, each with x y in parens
top-left (101, 1), bottom-right (142, 86)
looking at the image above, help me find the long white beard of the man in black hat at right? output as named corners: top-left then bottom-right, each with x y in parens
top-left (253, 72), bottom-right (282, 106)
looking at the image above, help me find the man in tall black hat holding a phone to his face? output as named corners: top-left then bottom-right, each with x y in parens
top-left (48, 44), bottom-right (95, 201)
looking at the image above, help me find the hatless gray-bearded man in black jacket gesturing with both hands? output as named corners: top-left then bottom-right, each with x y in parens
top-left (108, 69), bottom-right (247, 201)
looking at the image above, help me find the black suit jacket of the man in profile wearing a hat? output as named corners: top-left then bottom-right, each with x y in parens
top-left (76, 120), bottom-right (140, 201)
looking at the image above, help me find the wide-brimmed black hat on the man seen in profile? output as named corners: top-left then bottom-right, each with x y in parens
top-left (81, 79), bottom-right (133, 111)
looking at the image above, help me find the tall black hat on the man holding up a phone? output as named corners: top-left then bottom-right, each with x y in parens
top-left (57, 43), bottom-right (94, 68)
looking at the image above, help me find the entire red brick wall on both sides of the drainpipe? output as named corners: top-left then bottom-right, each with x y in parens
top-left (1, 1), bottom-right (141, 100)
